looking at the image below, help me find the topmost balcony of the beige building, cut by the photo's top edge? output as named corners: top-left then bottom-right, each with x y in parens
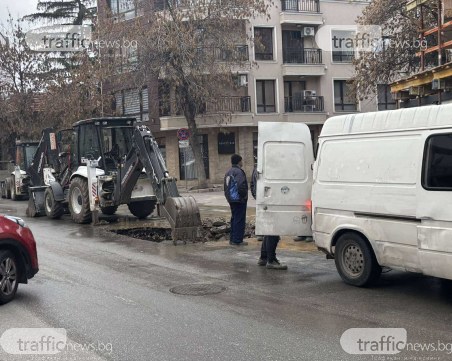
top-left (280, 0), bottom-right (323, 25)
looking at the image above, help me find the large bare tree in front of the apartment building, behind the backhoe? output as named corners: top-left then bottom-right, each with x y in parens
top-left (101, 0), bottom-right (272, 187)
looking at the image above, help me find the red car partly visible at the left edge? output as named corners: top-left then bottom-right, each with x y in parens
top-left (0, 215), bottom-right (39, 305)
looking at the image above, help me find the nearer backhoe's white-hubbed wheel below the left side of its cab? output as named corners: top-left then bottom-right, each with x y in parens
top-left (69, 177), bottom-right (92, 224)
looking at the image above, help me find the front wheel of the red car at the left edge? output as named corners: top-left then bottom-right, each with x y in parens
top-left (0, 251), bottom-right (19, 305)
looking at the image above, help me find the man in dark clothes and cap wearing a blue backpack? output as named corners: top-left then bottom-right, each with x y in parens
top-left (224, 154), bottom-right (248, 246)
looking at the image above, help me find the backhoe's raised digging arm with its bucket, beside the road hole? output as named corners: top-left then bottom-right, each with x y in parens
top-left (119, 125), bottom-right (201, 241)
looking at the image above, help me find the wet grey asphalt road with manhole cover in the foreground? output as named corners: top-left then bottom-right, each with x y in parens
top-left (0, 194), bottom-right (452, 361)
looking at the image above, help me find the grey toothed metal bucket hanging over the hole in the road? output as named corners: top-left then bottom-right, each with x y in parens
top-left (161, 197), bottom-right (201, 241)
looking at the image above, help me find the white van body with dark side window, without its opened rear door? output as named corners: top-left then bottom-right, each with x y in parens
top-left (312, 105), bottom-right (452, 286)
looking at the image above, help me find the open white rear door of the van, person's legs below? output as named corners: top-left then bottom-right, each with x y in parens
top-left (256, 122), bottom-right (314, 236)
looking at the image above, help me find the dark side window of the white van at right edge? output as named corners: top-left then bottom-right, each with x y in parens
top-left (422, 134), bottom-right (452, 190)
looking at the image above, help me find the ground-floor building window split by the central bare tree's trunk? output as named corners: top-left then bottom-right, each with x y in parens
top-left (179, 134), bottom-right (209, 180)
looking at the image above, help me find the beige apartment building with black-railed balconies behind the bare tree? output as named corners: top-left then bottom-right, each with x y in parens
top-left (99, 0), bottom-right (374, 185)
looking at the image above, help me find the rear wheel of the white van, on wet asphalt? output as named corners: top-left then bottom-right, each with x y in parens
top-left (334, 232), bottom-right (381, 287)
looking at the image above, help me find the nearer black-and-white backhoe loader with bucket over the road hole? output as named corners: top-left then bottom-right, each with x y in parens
top-left (29, 118), bottom-right (201, 240)
